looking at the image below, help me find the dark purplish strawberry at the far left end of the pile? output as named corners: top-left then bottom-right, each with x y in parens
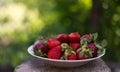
top-left (34, 42), bottom-right (48, 54)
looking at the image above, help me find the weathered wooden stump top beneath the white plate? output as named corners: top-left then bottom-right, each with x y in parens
top-left (14, 58), bottom-right (111, 72)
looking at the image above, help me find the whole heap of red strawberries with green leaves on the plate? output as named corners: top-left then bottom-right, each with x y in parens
top-left (33, 32), bottom-right (104, 60)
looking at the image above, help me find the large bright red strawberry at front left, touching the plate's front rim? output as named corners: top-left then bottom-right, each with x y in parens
top-left (48, 46), bottom-right (61, 59)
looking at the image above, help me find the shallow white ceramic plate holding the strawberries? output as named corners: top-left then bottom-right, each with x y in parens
top-left (28, 45), bottom-right (105, 67)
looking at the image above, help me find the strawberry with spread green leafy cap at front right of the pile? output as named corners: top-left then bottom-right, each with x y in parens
top-left (77, 45), bottom-right (93, 60)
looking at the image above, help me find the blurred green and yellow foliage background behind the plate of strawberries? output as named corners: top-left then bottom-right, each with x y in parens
top-left (0, 0), bottom-right (120, 72)
